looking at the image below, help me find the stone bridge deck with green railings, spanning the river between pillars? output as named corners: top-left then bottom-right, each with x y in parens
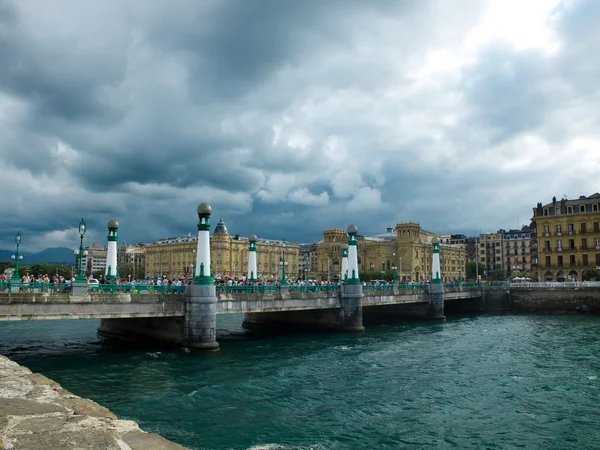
top-left (0, 282), bottom-right (483, 345)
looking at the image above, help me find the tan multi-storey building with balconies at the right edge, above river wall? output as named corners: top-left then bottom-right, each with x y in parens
top-left (531, 193), bottom-right (600, 281)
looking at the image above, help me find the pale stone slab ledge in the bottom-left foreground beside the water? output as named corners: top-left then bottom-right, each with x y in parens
top-left (0, 355), bottom-right (185, 450)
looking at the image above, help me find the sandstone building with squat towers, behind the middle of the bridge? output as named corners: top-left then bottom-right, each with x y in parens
top-left (310, 222), bottom-right (465, 282)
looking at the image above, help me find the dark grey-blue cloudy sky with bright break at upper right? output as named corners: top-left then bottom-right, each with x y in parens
top-left (0, 0), bottom-right (600, 251)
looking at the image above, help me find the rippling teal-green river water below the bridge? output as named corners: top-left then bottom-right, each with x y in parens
top-left (0, 315), bottom-right (600, 449)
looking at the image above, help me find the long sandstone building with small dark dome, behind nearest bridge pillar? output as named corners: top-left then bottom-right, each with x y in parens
top-left (145, 220), bottom-right (302, 281)
